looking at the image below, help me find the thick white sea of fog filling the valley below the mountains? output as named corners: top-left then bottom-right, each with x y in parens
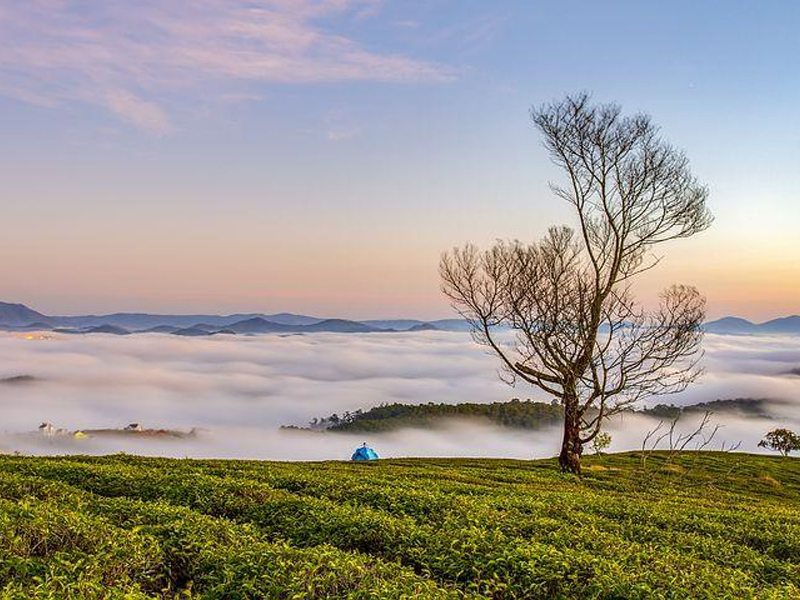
top-left (0, 332), bottom-right (800, 460)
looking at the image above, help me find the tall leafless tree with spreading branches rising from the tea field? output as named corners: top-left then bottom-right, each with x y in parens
top-left (440, 94), bottom-right (712, 474)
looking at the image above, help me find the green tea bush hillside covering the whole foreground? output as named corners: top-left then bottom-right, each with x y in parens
top-left (0, 453), bottom-right (800, 599)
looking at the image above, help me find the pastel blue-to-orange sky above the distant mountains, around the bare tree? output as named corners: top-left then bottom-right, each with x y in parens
top-left (0, 0), bottom-right (800, 320)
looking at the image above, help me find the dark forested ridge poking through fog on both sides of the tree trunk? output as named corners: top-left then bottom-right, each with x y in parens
top-left (296, 398), bottom-right (770, 432)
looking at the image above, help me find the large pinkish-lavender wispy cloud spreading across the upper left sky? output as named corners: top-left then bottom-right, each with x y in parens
top-left (0, 0), bottom-right (455, 133)
